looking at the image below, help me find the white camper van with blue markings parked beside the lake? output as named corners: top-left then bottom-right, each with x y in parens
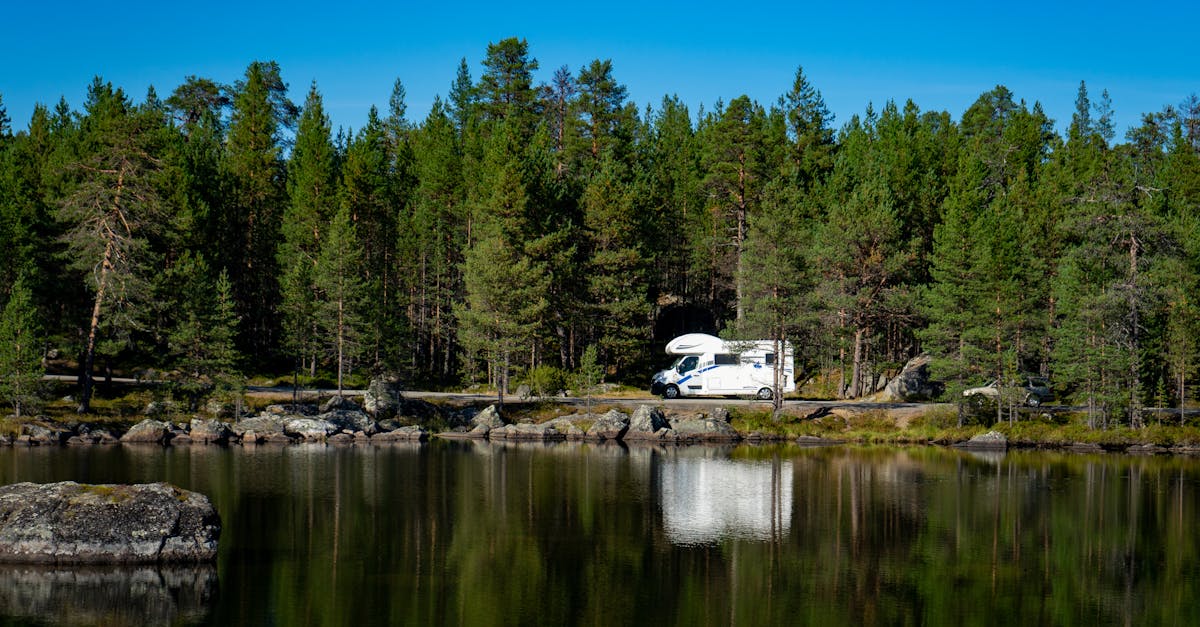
top-left (650, 333), bottom-right (796, 400)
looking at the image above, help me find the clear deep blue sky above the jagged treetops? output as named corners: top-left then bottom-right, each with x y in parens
top-left (0, 0), bottom-right (1200, 138)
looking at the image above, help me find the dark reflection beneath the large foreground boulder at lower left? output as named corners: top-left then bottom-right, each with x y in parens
top-left (0, 565), bottom-right (217, 626)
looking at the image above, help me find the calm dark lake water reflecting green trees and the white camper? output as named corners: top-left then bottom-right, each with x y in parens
top-left (0, 441), bottom-right (1200, 626)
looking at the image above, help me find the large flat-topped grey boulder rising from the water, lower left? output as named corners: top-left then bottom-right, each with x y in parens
top-left (0, 482), bottom-right (221, 563)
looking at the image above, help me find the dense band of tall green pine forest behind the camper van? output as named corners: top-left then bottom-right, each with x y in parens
top-left (0, 38), bottom-right (1200, 428)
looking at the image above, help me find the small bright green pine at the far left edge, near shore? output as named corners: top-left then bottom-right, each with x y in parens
top-left (0, 276), bottom-right (44, 418)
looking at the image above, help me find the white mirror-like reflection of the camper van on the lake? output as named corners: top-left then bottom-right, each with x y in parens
top-left (659, 449), bottom-right (792, 544)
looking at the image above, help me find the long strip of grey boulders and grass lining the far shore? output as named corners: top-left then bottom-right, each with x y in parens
top-left (0, 396), bottom-right (1200, 455)
